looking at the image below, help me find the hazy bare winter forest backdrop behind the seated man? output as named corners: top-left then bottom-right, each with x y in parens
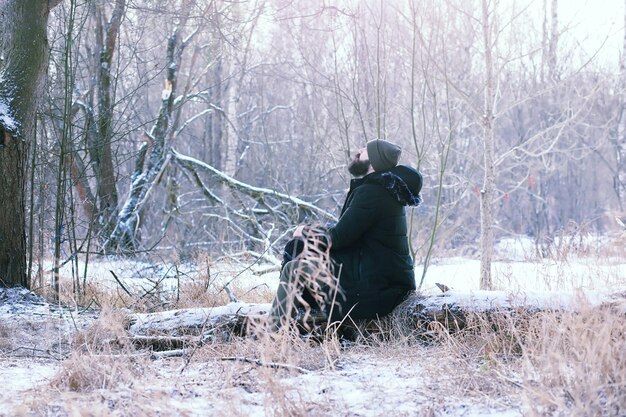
top-left (2, 0), bottom-right (626, 285)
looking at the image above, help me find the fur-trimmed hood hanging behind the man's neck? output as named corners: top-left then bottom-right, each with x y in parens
top-left (364, 165), bottom-right (422, 206)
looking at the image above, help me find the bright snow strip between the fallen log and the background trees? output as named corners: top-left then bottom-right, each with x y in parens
top-left (42, 234), bottom-right (626, 299)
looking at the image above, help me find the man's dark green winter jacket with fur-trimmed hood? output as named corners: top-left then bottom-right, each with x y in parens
top-left (329, 166), bottom-right (422, 319)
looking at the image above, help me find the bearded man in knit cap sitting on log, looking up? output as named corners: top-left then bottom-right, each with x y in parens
top-left (271, 139), bottom-right (422, 328)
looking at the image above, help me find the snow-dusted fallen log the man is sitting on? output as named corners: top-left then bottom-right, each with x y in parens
top-left (128, 290), bottom-right (626, 342)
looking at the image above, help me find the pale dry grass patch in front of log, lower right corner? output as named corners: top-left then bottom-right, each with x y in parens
top-left (416, 301), bottom-right (626, 417)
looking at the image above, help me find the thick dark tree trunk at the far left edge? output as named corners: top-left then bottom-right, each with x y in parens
top-left (0, 0), bottom-right (58, 287)
